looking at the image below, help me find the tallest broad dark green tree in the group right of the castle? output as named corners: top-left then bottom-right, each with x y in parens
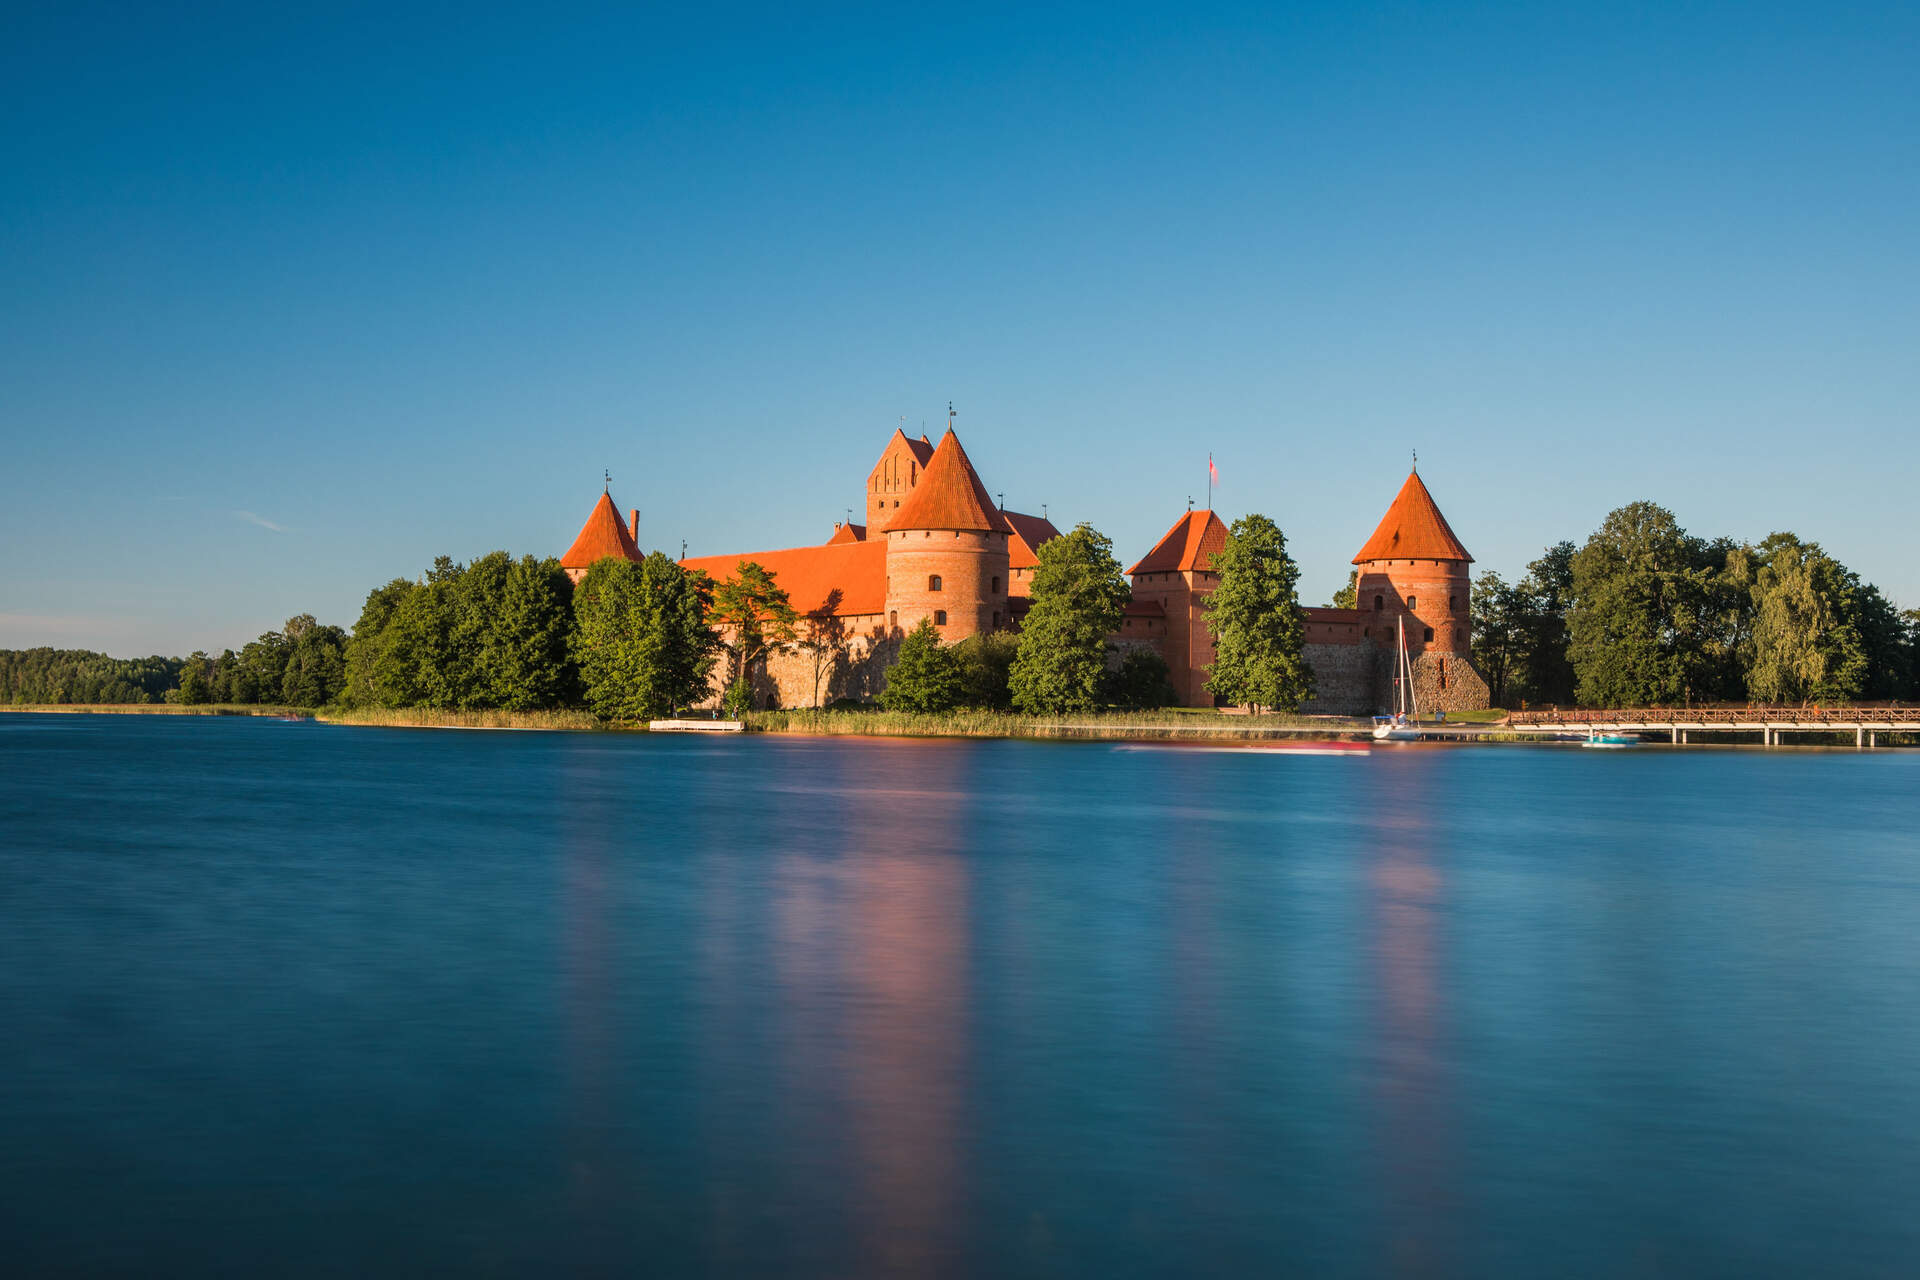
top-left (1567, 503), bottom-right (1715, 706)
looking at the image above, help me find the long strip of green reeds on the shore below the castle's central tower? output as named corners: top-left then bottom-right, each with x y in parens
top-left (745, 708), bottom-right (1365, 739)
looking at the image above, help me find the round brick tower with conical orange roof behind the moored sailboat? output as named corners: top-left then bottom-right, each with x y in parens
top-left (1354, 472), bottom-right (1486, 712)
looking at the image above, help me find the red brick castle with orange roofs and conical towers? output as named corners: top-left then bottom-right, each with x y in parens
top-left (561, 426), bottom-right (1488, 716)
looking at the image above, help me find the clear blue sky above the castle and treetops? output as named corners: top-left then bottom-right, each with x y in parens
top-left (0, 2), bottom-right (1920, 656)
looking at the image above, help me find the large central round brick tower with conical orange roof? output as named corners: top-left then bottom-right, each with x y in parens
top-left (870, 428), bottom-right (1010, 643)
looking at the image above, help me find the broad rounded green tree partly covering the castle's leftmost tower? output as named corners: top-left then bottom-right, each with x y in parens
top-left (574, 551), bottom-right (714, 720)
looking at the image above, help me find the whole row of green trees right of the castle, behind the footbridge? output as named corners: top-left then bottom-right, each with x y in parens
top-left (1473, 503), bottom-right (1920, 706)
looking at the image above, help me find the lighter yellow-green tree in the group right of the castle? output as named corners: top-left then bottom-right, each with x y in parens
top-left (1747, 533), bottom-right (1868, 702)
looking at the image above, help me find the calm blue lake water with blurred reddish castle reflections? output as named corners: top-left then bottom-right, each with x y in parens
top-left (0, 716), bottom-right (1920, 1276)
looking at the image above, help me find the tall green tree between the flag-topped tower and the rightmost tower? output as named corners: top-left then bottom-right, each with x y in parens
top-left (1202, 514), bottom-right (1313, 710)
